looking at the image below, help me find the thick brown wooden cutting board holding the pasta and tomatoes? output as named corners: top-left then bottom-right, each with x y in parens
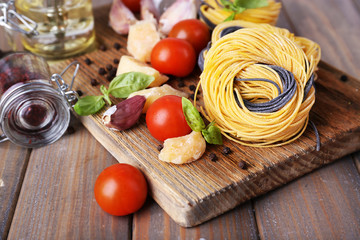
top-left (51, 7), bottom-right (360, 227)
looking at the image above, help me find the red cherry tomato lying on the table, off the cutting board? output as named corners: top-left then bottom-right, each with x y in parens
top-left (94, 163), bottom-right (148, 216)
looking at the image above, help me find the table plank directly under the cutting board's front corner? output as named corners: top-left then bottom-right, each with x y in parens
top-left (133, 198), bottom-right (259, 240)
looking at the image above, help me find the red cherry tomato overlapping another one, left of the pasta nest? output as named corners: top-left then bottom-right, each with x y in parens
top-left (151, 38), bottom-right (196, 77)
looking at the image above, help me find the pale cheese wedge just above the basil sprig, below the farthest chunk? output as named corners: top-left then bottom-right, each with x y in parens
top-left (116, 55), bottom-right (169, 87)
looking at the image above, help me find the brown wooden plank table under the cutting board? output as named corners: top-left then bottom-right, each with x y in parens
top-left (0, 0), bottom-right (360, 239)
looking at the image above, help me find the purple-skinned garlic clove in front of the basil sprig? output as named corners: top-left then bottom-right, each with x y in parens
top-left (102, 95), bottom-right (146, 131)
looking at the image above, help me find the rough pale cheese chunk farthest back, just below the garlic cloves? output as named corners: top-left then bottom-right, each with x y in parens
top-left (127, 20), bottom-right (160, 62)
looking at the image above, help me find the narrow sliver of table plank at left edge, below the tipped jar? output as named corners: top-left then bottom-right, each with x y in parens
top-left (0, 142), bottom-right (31, 239)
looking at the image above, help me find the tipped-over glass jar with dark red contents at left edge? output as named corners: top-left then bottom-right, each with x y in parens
top-left (0, 53), bottom-right (76, 147)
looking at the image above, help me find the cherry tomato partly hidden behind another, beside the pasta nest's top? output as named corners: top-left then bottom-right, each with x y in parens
top-left (169, 19), bottom-right (210, 54)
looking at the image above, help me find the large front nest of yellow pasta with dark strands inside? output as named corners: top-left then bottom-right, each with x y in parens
top-left (195, 21), bottom-right (320, 147)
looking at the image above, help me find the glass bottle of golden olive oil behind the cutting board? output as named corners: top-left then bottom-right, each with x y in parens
top-left (15, 0), bottom-right (95, 59)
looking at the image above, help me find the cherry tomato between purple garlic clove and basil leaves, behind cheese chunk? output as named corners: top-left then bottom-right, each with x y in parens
top-left (146, 95), bottom-right (191, 142)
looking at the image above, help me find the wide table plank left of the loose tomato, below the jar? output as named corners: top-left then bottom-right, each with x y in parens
top-left (9, 118), bottom-right (131, 239)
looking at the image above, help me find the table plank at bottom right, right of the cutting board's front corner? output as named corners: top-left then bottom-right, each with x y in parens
top-left (255, 157), bottom-right (360, 239)
